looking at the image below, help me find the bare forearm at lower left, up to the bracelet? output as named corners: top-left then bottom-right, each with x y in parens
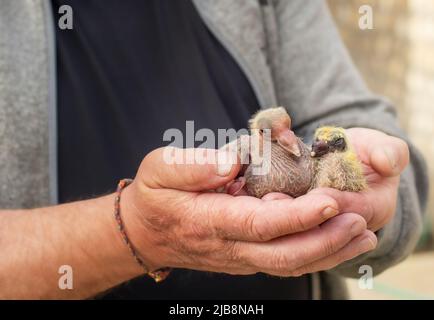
top-left (0, 195), bottom-right (143, 299)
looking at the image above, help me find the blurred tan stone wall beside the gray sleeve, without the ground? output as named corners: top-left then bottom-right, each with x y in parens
top-left (328, 0), bottom-right (434, 246)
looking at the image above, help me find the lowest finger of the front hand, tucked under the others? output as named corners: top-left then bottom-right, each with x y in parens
top-left (291, 230), bottom-right (377, 277)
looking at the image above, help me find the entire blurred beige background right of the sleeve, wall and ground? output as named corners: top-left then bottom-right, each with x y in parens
top-left (328, 0), bottom-right (434, 299)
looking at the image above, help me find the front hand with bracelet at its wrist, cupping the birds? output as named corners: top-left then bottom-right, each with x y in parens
top-left (121, 148), bottom-right (376, 276)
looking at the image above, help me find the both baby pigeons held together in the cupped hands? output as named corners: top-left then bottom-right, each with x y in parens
top-left (223, 107), bottom-right (367, 198)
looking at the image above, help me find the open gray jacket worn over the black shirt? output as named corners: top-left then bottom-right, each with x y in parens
top-left (0, 0), bottom-right (428, 298)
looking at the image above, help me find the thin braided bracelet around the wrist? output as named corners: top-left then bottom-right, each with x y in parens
top-left (114, 179), bottom-right (171, 282)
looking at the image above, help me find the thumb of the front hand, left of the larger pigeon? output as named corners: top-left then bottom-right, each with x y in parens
top-left (139, 147), bottom-right (240, 191)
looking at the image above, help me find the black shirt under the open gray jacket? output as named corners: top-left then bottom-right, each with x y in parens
top-left (52, 0), bottom-right (310, 299)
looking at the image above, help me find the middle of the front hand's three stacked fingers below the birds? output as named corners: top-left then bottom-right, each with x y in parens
top-left (236, 213), bottom-right (366, 276)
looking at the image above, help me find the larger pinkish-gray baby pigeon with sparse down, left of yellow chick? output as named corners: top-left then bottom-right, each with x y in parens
top-left (244, 107), bottom-right (314, 198)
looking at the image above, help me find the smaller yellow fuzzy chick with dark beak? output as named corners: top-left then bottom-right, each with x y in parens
top-left (311, 126), bottom-right (367, 192)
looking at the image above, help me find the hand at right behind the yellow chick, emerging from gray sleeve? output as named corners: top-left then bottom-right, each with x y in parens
top-left (313, 128), bottom-right (409, 231)
